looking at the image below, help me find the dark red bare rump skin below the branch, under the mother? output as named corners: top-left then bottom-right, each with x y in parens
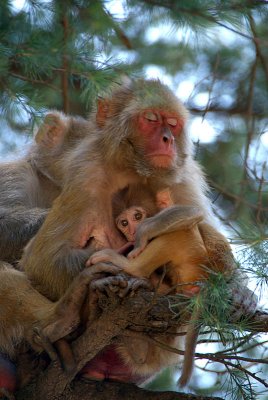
top-left (80, 345), bottom-right (150, 384)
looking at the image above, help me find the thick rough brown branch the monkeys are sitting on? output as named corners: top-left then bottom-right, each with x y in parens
top-left (17, 291), bottom-right (268, 400)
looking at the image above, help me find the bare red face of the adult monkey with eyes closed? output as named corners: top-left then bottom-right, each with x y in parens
top-left (138, 109), bottom-right (184, 168)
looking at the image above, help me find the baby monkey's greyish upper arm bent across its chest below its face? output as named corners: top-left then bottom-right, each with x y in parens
top-left (128, 206), bottom-right (203, 259)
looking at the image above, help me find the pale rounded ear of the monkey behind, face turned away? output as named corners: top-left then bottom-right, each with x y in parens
top-left (35, 113), bottom-right (65, 149)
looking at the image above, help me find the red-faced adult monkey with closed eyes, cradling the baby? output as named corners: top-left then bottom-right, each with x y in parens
top-left (21, 80), bottom-right (224, 382)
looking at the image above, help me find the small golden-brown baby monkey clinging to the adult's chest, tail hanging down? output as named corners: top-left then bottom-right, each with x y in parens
top-left (87, 185), bottom-right (234, 386)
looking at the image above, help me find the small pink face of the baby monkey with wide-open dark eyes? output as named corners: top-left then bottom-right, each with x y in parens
top-left (116, 206), bottom-right (147, 242)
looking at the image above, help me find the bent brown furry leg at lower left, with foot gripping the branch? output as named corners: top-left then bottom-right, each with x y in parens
top-left (0, 263), bottom-right (122, 376)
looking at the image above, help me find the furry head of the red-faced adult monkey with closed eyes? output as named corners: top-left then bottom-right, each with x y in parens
top-left (96, 80), bottom-right (191, 177)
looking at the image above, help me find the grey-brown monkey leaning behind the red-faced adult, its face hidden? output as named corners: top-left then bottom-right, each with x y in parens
top-left (0, 111), bottom-right (89, 262)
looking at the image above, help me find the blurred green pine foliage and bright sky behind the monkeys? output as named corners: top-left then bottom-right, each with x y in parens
top-left (0, 0), bottom-right (268, 399)
